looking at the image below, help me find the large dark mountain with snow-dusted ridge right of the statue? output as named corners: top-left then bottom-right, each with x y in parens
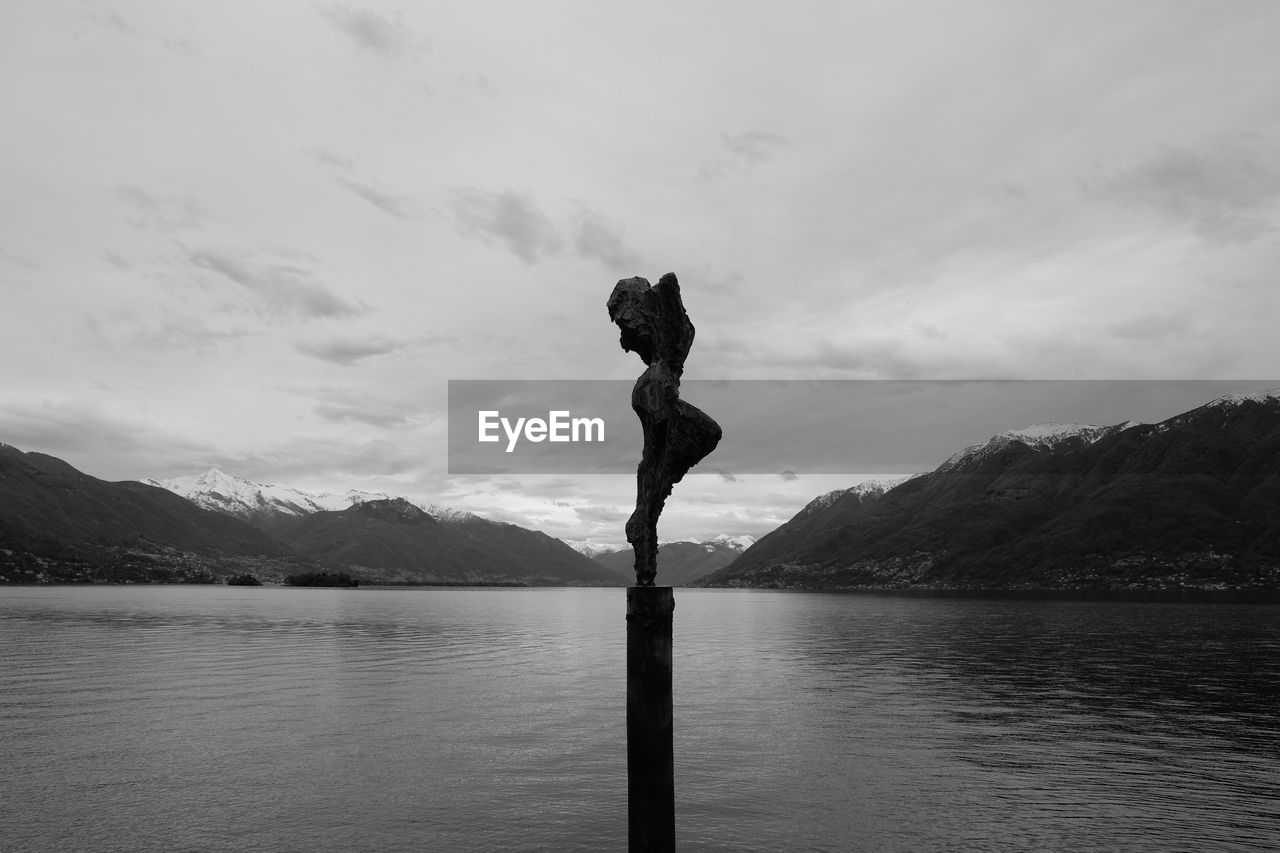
top-left (705, 392), bottom-right (1280, 589)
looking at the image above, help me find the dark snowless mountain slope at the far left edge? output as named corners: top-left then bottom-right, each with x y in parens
top-left (0, 444), bottom-right (288, 581)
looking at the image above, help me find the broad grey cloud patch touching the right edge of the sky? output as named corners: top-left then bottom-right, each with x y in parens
top-left (1085, 136), bottom-right (1280, 243)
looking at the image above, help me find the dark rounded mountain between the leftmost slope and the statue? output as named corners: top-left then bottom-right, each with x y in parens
top-left (275, 498), bottom-right (622, 587)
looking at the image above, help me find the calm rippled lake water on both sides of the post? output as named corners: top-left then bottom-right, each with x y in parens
top-left (0, 587), bottom-right (1280, 853)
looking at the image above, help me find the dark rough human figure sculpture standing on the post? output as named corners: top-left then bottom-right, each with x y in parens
top-left (608, 273), bottom-right (721, 587)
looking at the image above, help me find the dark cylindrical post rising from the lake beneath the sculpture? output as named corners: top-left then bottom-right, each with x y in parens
top-left (627, 587), bottom-right (676, 853)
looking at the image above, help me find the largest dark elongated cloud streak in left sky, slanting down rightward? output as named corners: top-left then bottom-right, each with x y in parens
top-left (187, 248), bottom-right (367, 318)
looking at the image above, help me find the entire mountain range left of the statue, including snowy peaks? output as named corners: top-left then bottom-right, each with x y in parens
top-left (0, 444), bottom-right (622, 585)
